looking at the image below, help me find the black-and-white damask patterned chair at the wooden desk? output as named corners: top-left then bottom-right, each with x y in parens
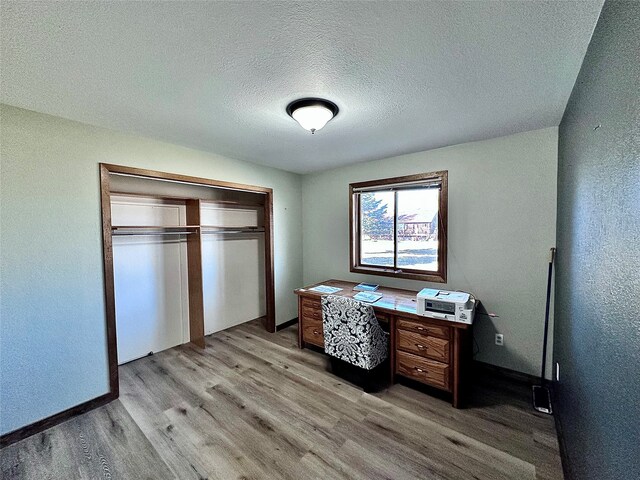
top-left (322, 295), bottom-right (389, 391)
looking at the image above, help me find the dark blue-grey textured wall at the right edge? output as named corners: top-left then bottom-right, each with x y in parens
top-left (554, 1), bottom-right (640, 480)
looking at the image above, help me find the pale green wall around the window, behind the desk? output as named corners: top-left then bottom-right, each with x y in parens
top-left (302, 128), bottom-right (558, 375)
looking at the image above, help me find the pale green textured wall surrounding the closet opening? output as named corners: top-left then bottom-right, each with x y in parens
top-left (0, 105), bottom-right (302, 433)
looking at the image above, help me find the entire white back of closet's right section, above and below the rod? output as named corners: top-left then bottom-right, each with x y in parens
top-left (201, 202), bottom-right (266, 335)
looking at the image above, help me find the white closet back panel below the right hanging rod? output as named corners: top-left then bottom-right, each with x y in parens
top-left (202, 235), bottom-right (266, 335)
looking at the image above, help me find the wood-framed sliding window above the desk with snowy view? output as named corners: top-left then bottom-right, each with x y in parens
top-left (349, 171), bottom-right (447, 282)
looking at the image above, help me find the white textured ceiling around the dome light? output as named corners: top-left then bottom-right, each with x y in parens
top-left (0, 0), bottom-right (602, 172)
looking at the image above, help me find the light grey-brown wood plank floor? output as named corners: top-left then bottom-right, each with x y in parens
top-left (0, 323), bottom-right (562, 480)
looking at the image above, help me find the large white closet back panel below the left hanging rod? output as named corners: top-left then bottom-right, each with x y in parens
top-left (113, 237), bottom-right (188, 364)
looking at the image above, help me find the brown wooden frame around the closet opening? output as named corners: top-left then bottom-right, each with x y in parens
top-left (100, 163), bottom-right (276, 399)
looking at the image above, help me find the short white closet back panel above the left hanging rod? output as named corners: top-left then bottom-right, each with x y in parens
top-left (111, 198), bottom-right (185, 227)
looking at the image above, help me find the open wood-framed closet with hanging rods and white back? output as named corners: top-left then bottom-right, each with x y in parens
top-left (101, 164), bottom-right (275, 374)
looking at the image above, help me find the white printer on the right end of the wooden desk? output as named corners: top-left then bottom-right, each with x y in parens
top-left (417, 288), bottom-right (476, 324)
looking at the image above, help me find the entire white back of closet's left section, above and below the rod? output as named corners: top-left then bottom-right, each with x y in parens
top-left (111, 197), bottom-right (189, 364)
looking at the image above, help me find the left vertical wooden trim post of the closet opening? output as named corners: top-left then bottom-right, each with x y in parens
top-left (100, 164), bottom-right (120, 398)
